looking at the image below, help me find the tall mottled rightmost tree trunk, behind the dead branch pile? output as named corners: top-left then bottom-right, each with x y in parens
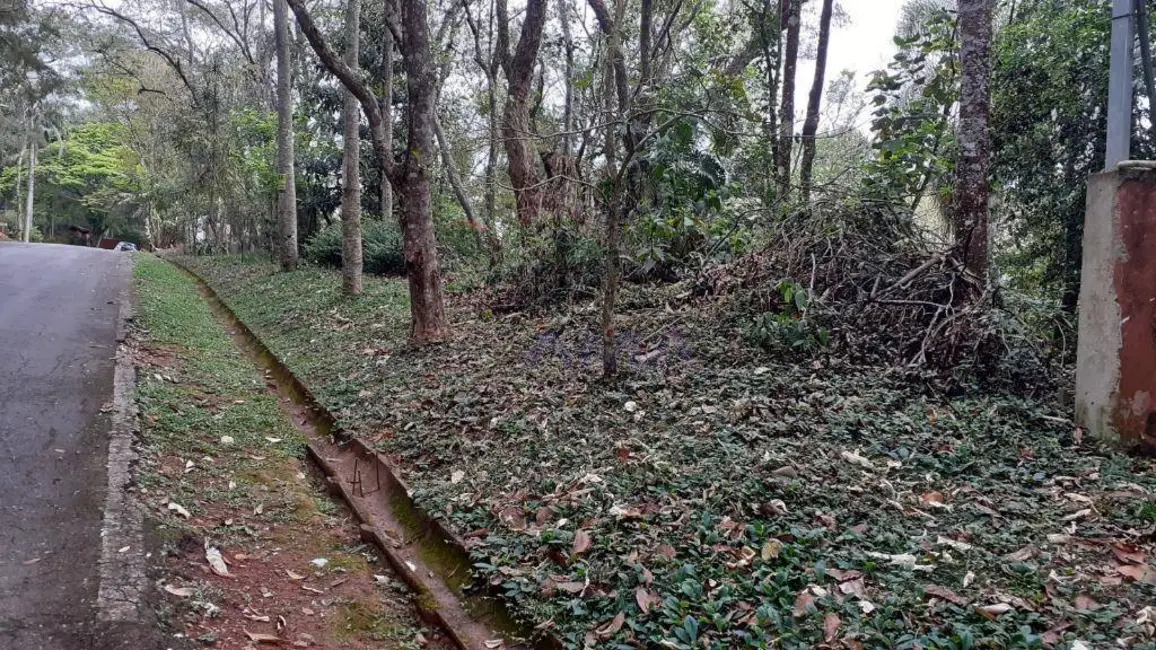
top-left (955, 0), bottom-right (992, 282)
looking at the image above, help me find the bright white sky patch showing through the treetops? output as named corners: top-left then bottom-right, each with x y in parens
top-left (795, 0), bottom-right (905, 128)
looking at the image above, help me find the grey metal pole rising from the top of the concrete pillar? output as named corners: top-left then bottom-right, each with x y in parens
top-left (1104, 0), bottom-right (1135, 169)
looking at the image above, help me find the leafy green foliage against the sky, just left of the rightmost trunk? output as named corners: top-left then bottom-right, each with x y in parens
top-left (864, 9), bottom-right (959, 209)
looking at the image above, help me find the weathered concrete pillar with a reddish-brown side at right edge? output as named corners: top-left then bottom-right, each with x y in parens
top-left (1075, 162), bottom-right (1156, 449)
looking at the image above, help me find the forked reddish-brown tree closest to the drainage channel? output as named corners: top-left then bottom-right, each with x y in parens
top-left (287, 0), bottom-right (450, 344)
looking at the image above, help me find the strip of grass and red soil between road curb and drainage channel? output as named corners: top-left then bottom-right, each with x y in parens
top-left (135, 256), bottom-right (436, 649)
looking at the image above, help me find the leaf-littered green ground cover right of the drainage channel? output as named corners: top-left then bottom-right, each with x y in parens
top-left (180, 258), bottom-right (1156, 648)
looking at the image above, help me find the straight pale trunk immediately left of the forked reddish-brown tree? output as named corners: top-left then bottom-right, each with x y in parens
top-left (341, 0), bottom-right (362, 296)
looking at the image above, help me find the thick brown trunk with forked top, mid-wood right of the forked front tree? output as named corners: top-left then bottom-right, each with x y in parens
top-left (497, 0), bottom-right (547, 228)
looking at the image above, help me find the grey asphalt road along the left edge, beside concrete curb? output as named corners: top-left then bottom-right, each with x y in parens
top-left (0, 242), bottom-right (160, 650)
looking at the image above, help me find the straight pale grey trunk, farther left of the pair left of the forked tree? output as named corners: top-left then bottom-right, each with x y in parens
top-left (273, 0), bottom-right (297, 271)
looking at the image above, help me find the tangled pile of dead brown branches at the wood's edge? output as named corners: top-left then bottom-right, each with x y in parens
top-left (699, 205), bottom-right (1054, 392)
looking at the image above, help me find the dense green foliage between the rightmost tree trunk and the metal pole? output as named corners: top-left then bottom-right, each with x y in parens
top-left (992, 0), bottom-right (1114, 309)
